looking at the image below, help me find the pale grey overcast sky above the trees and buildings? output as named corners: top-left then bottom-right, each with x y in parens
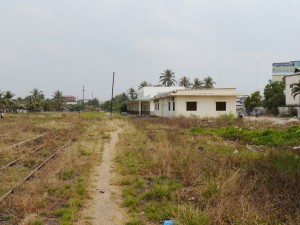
top-left (0, 0), bottom-right (300, 100)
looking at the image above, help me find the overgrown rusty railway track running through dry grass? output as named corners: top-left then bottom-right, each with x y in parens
top-left (0, 130), bottom-right (74, 203)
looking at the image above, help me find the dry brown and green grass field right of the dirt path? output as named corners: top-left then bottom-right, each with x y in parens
top-left (117, 115), bottom-right (300, 225)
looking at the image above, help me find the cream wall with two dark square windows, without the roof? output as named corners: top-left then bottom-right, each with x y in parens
top-left (155, 96), bottom-right (236, 117)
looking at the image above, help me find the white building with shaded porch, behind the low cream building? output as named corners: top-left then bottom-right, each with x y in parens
top-left (127, 87), bottom-right (184, 115)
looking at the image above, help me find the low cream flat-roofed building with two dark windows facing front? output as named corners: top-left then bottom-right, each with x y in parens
top-left (154, 88), bottom-right (237, 117)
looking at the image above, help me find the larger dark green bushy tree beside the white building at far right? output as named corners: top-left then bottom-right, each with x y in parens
top-left (263, 81), bottom-right (285, 115)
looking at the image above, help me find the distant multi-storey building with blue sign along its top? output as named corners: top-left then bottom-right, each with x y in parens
top-left (272, 61), bottom-right (300, 81)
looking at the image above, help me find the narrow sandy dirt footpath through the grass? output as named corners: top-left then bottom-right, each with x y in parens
top-left (75, 123), bottom-right (127, 225)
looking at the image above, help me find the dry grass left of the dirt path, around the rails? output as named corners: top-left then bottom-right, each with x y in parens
top-left (0, 113), bottom-right (112, 225)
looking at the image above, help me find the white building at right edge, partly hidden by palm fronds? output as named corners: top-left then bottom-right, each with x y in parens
top-left (285, 72), bottom-right (300, 106)
